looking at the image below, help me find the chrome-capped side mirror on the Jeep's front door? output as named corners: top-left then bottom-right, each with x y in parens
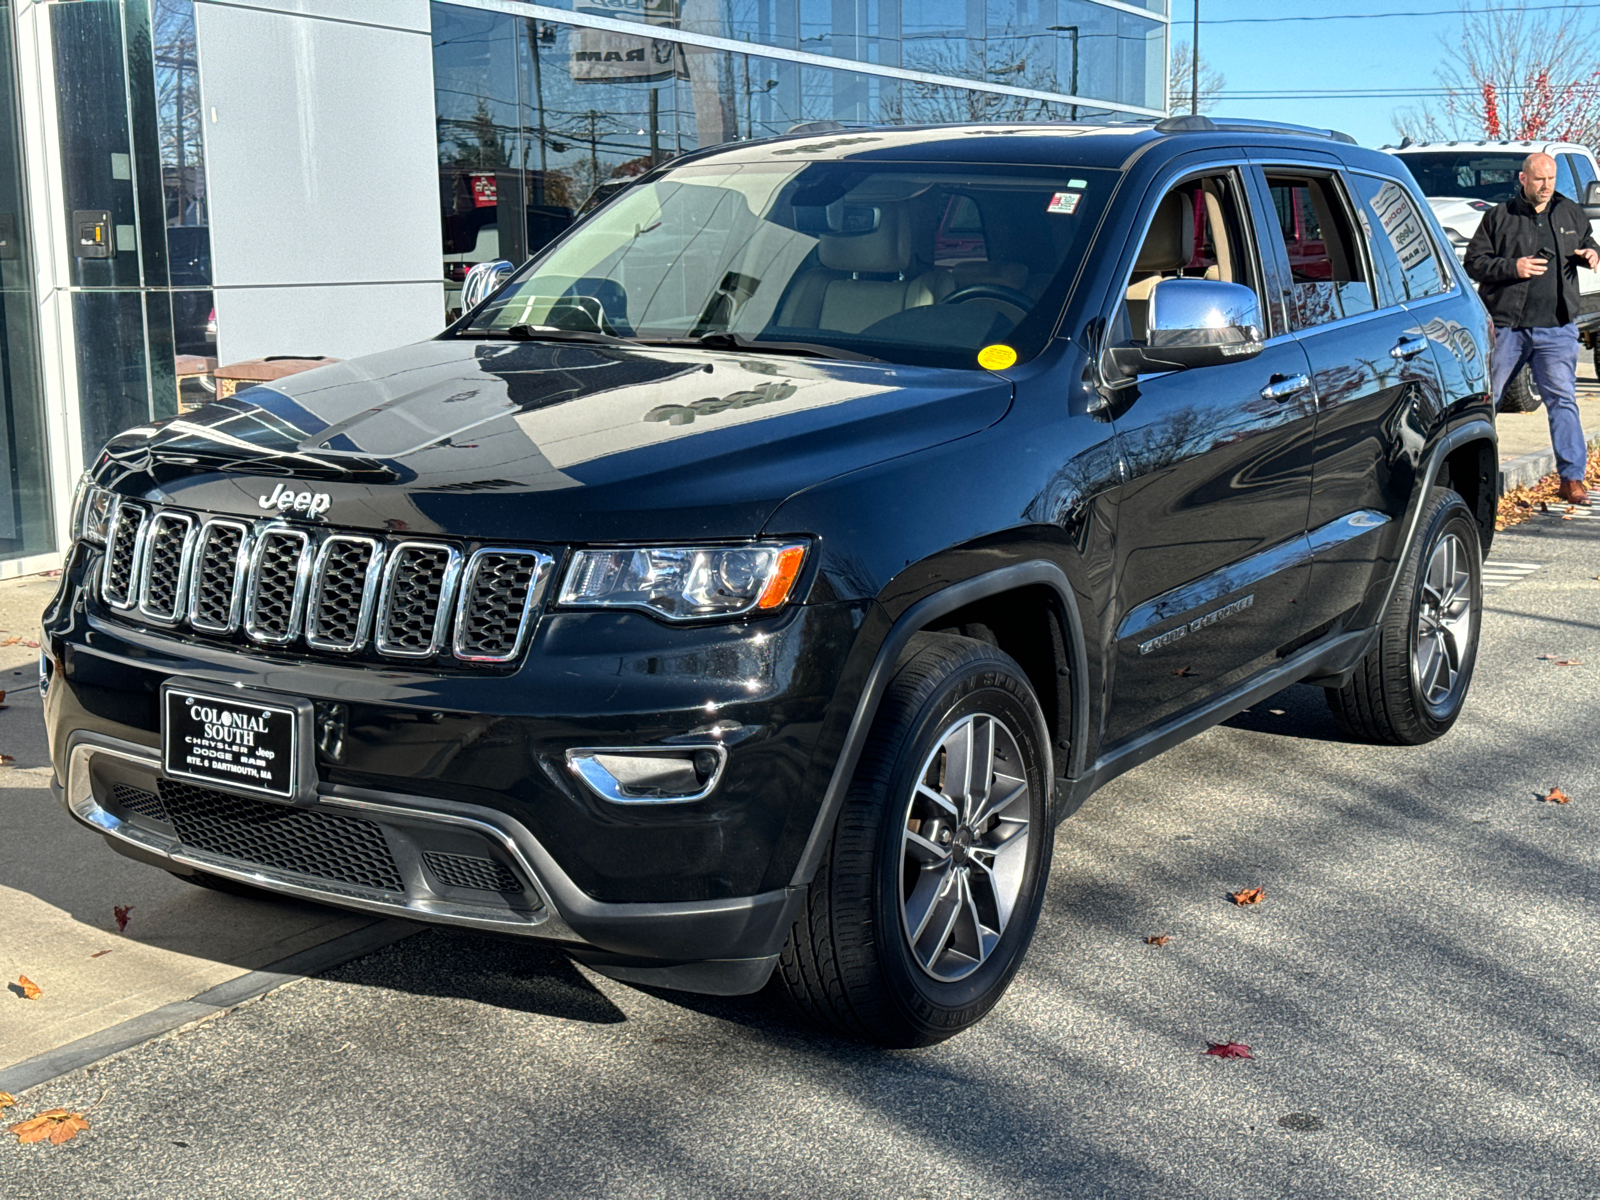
top-left (1110, 278), bottom-right (1266, 376)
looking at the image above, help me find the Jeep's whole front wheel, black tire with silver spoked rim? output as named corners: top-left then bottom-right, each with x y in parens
top-left (778, 634), bottom-right (1054, 1048)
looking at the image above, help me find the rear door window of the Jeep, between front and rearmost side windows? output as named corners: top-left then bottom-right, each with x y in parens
top-left (1267, 171), bottom-right (1376, 330)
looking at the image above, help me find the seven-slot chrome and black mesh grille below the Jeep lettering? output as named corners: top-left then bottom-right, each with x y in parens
top-left (99, 502), bottom-right (555, 664)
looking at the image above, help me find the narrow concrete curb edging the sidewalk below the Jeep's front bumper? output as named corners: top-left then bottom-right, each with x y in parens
top-left (0, 920), bottom-right (422, 1096)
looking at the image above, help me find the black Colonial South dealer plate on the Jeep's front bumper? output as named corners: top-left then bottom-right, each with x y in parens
top-left (162, 685), bottom-right (301, 800)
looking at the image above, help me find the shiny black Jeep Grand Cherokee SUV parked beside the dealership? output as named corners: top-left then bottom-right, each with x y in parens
top-left (42, 118), bottom-right (1496, 1045)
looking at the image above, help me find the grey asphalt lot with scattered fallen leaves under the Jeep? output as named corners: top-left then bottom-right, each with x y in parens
top-left (0, 499), bottom-right (1600, 1200)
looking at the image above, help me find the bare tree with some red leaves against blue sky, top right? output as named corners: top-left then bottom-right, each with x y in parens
top-left (1394, 3), bottom-right (1600, 146)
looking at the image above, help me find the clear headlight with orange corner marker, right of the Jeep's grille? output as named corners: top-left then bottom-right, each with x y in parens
top-left (562, 542), bottom-right (806, 621)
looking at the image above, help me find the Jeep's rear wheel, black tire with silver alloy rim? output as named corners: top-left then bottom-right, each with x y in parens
top-left (1326, 488), bottom-right (1483, 746)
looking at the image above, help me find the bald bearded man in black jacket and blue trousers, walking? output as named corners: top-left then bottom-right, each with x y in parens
top-left (1466, 154), bottom-right (1600, 504)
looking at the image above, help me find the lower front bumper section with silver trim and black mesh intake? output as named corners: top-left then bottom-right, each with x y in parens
top-left (56, 733), bottom-right (805, 994)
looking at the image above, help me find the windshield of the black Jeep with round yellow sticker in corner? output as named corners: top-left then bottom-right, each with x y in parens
top-left (454, 163), bottom-right (1115, 366)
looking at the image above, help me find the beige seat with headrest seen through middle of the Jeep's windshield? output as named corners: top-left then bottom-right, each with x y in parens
top-left (778, 205), bottom-right (955, 333)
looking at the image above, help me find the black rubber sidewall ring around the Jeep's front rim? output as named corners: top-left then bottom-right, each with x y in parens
top-left (872, 656), bottom-right (1054, 1037)
